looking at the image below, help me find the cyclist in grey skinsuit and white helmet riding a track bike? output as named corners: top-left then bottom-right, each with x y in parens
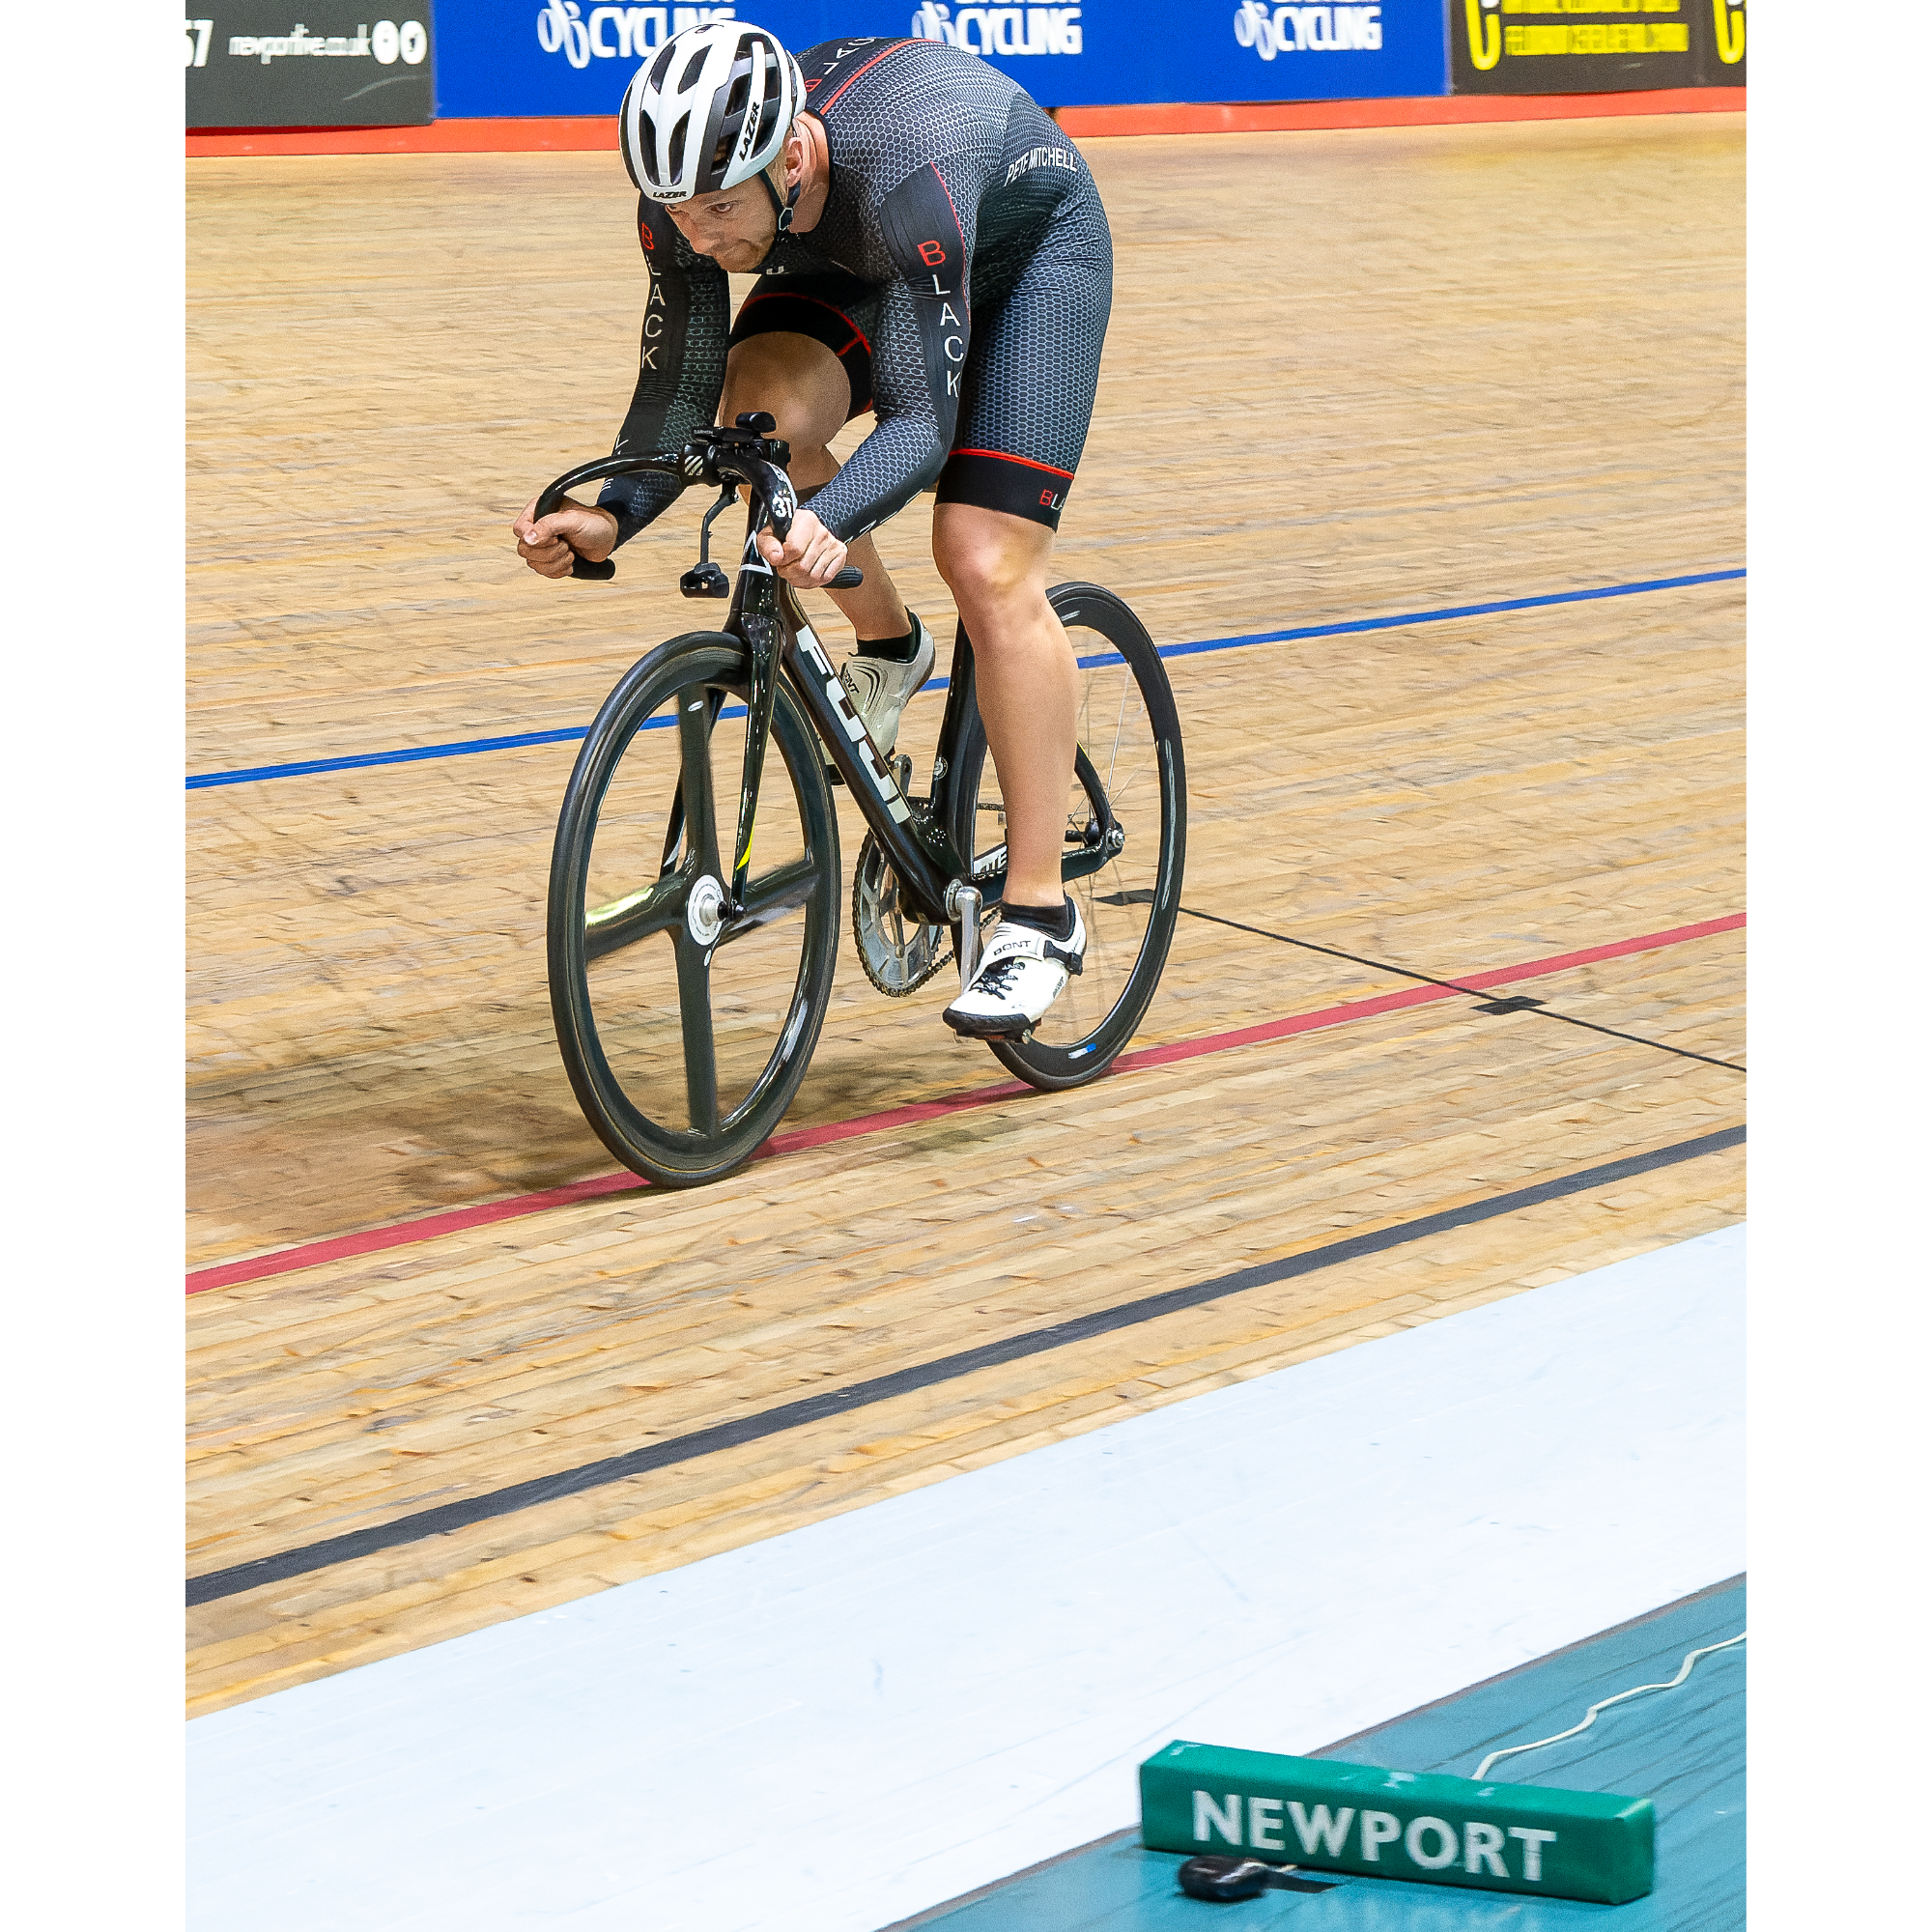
top-left (514, 19), bottom-right (1113, 1037)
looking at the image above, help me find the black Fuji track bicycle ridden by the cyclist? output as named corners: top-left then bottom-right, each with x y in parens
top-left (535, 412), bottom-right (1186, 1186)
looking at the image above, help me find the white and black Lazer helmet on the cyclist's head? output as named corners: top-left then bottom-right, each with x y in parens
top-left (618, 19), bottom-right (806, 201)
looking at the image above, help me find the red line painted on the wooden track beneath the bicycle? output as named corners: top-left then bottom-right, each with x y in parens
top-left (187, 912), bottom-right (1745, 1294)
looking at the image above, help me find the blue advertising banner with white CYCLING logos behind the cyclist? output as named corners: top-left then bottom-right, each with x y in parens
top-left (437, 0), bottom-right (1449, 120)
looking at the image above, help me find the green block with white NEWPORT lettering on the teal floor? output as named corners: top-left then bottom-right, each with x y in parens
top-left (1140, 1741), bottom-right (1656, 1905)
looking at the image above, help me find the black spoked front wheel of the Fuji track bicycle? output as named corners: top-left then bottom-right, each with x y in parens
top-left (549, 632), bottom-right (838, 1186)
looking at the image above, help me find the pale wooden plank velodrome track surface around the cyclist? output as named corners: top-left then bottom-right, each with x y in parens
top-left (187, 116), bottom-right (1745, 1712)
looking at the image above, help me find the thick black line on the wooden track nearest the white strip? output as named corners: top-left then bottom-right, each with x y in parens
top-left (187, 1126), bottom-right (1745, 1609)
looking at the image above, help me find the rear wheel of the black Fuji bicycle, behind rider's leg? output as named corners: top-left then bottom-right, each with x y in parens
top-left (951, 583), bottom-right (1188, 1092)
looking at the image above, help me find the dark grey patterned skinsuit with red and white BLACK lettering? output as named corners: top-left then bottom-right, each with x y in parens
top-left (599, 41), bottom-right (1113, 543)
